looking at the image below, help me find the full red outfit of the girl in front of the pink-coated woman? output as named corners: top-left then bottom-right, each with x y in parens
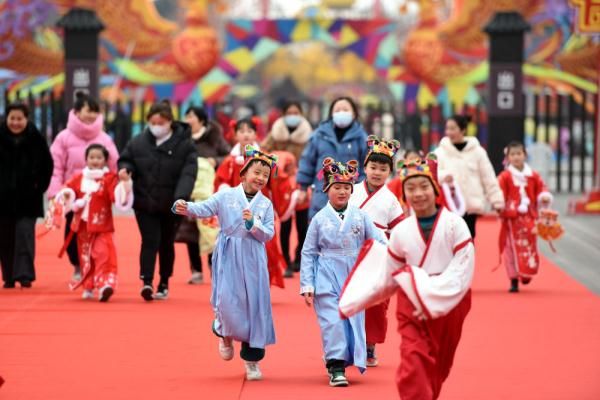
top-left (66, 172), bottom-right (119, 290)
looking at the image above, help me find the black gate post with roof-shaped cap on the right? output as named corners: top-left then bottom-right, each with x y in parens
top-left (484, 11), bottom-right (530, 173)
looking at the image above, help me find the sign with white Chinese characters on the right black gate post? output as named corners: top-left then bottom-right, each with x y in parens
top-left (488, 64), bottom-right (523, 116)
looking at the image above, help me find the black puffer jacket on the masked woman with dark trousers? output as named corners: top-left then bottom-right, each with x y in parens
top-left (119, 122), bottom-right (198, 213)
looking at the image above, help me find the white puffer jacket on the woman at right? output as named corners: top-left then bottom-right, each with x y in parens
top-left (435, 137), bottom-right (504, 214)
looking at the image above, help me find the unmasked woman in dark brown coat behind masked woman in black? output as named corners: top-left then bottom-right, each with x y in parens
top-left (177, 107), bottom-right (231, 285)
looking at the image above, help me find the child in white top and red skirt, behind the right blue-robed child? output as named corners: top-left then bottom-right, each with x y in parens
top-left (350, 135), bottom-right (403, 367)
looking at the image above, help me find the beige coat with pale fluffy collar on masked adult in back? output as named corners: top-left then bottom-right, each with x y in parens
top-left (261, 117), bottom-right (313, 160)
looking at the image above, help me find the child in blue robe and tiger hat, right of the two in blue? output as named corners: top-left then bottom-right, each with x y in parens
top-left (300, 158), bottom-right (385, 386)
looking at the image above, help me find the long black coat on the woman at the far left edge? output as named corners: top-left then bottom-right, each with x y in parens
top-left (0, 122), bottom-right (54, 218)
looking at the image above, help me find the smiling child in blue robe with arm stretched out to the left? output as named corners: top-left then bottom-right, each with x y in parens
top-left (173, 145), bottom-right (277, 380)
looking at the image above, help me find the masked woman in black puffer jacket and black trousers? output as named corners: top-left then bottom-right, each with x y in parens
top-left (119, 101), bottom-right (198, 301)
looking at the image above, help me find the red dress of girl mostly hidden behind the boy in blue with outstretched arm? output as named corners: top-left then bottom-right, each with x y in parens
top-left (215, 155), bottom-right (287, 288)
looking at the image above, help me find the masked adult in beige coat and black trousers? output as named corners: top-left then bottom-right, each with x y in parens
top-left (261, 101), bottom-right (312, 278)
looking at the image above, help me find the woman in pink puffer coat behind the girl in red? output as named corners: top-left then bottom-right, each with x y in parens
top-left (47, 92), bottom-right (119, 281)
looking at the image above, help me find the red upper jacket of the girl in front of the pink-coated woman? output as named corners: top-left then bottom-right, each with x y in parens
top-left (66, 172), bottom-right (119, 233)
